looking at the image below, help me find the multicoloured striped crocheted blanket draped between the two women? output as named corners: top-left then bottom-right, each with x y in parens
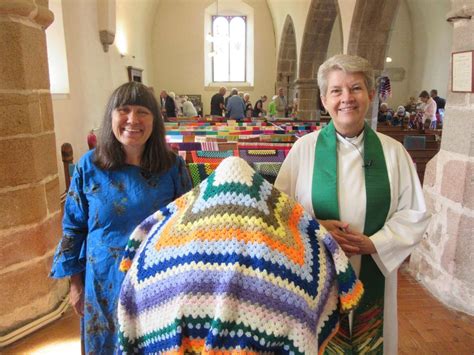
top-left (118, 157), bottom-right (363, 355)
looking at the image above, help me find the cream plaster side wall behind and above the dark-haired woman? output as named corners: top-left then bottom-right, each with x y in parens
top-left (53, 0), bottom-right (159, 191)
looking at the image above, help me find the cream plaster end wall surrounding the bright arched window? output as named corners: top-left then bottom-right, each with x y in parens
top-left (152, 0), bottom-right (276, 114)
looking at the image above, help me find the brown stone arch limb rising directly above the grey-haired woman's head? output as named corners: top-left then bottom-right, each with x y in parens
top-left (347, 0), bottom-right (399, 71)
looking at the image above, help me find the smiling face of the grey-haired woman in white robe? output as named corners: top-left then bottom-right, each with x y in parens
top-left (321, 70), bottom-right (374, 137)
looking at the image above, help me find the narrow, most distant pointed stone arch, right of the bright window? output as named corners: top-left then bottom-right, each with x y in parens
top-left (275, 15), bottom-right (298, 102)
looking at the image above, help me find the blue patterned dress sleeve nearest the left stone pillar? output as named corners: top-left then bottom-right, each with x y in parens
top-left (50, 163), bottom-right (89, 278)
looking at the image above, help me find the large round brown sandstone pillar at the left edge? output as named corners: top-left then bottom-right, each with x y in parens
top-left (0, 0), bottom-right (68, 342)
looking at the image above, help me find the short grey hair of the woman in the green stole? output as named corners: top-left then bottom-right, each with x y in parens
top-left (318, 54), bottom-right (374, 96)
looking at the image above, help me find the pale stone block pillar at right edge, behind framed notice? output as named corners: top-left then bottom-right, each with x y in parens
top-left (410, 0), bottom-right (474, 314)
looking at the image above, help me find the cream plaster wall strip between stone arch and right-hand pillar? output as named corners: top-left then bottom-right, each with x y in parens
top-left (406, 0), bottom-right (453, 98)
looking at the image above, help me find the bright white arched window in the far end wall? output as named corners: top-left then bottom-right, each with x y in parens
top-left (211, 16), bottom-right (247, 82)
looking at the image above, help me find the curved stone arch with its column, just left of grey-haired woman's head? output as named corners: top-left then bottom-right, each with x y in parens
top-left (295, 0), bottom-right (339, 119)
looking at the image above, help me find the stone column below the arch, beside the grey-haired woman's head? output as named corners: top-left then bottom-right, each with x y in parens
top-left (295, 79), bottom-right (319, 121)
